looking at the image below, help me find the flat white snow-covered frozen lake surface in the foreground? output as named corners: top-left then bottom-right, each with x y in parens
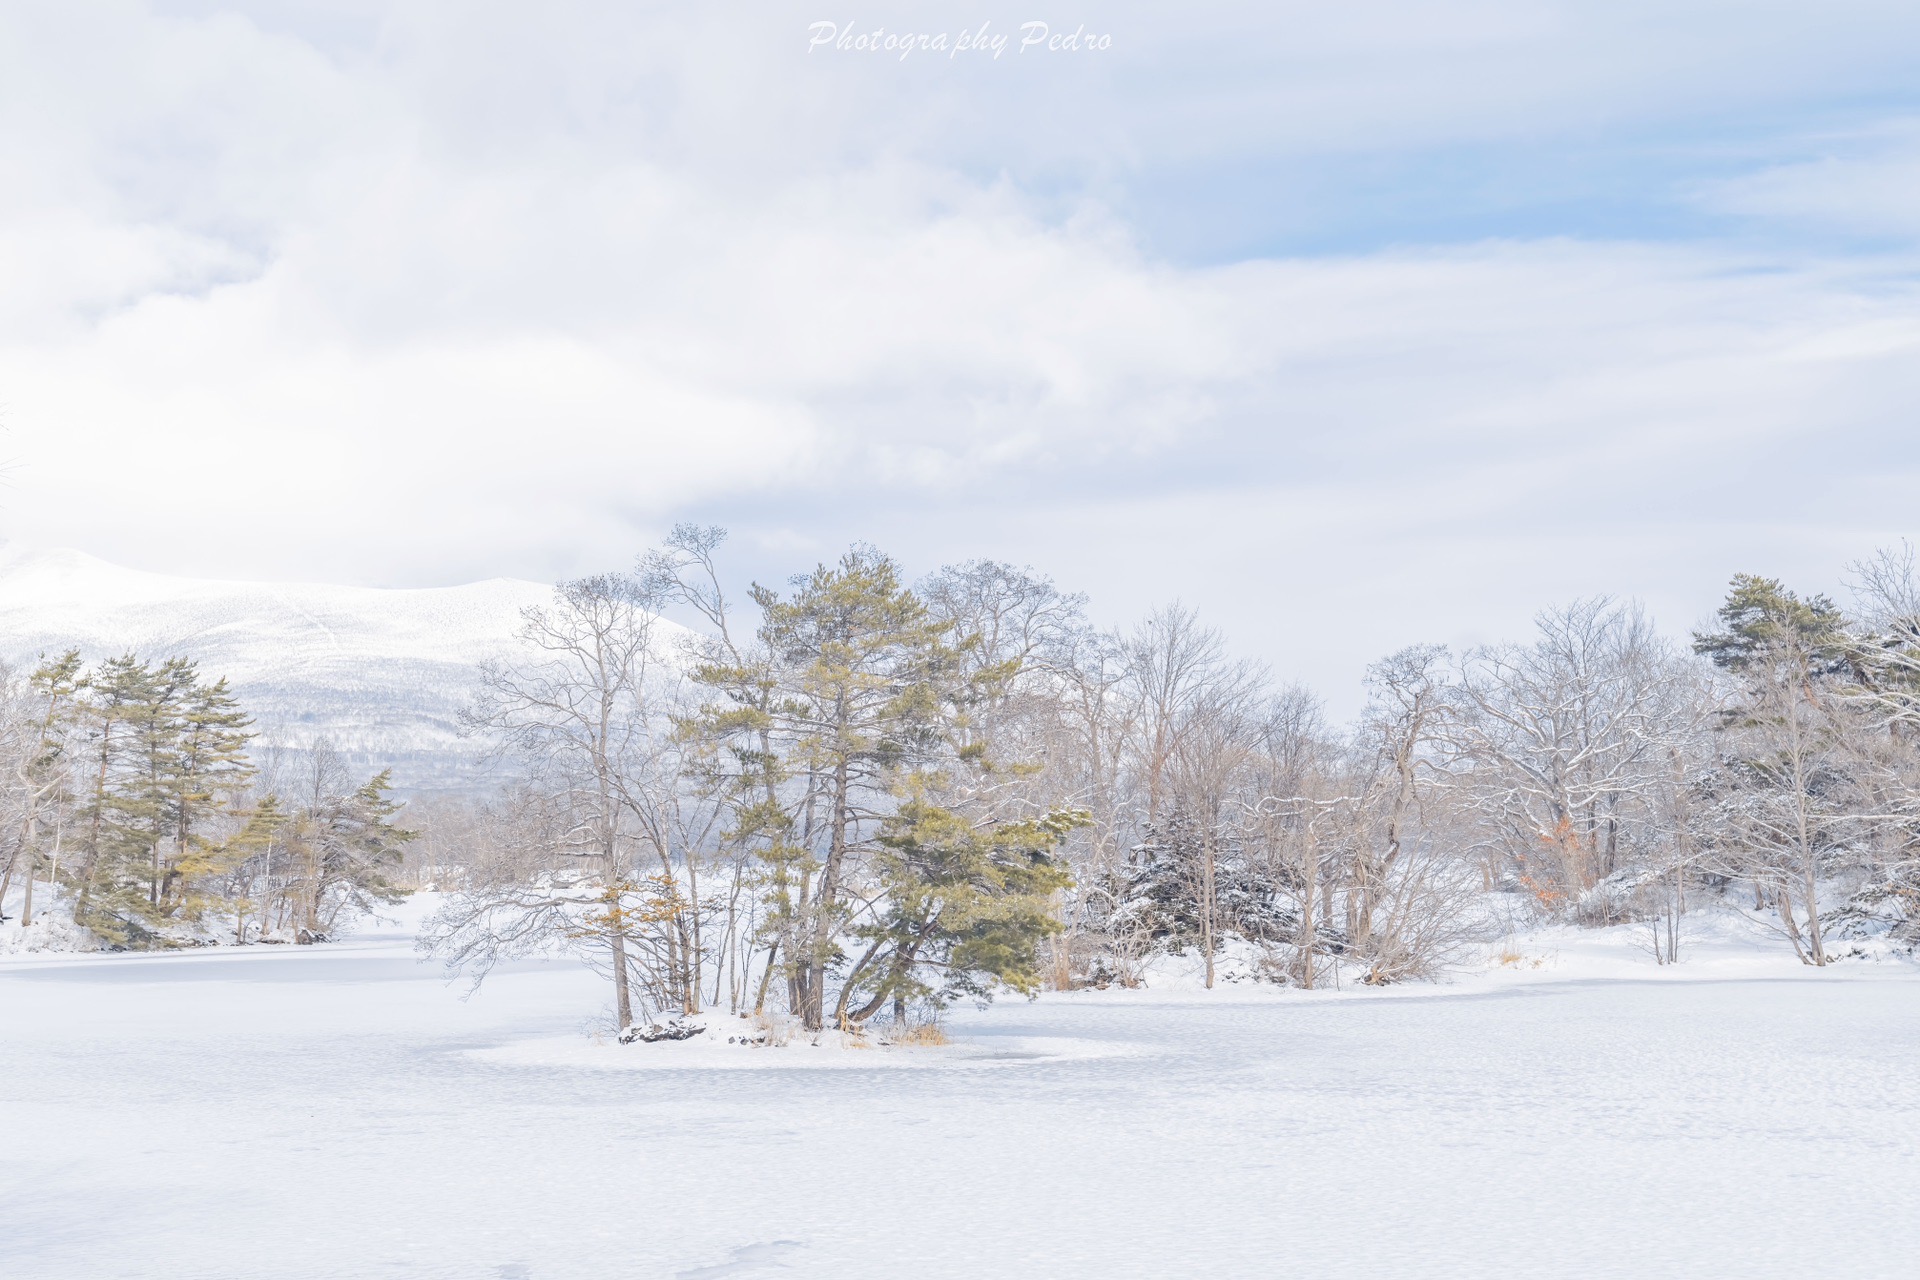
top-left (0, 901), bottom-right (1920, 1280)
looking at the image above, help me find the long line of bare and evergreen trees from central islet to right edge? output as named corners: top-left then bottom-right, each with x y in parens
top-left (422, 526), bottom-right (1920, 1031)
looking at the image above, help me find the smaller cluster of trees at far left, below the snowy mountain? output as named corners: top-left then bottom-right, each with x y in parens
top-left (0, 651), bottom-right (413, 948)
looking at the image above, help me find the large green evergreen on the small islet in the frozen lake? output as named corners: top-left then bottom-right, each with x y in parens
top-left (668, 533), bottom-right (1083, 1029)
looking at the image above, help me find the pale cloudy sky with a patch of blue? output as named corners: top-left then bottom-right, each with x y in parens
top-left (0, 0), bottom-right (1920, 706)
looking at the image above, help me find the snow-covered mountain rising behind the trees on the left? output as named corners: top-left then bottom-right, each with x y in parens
top-left (0, 545), bottom-right (553, 789)
